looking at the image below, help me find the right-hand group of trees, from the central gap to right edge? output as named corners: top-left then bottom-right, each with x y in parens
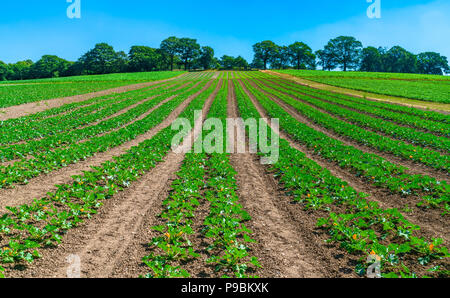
top-left (251, 36), bottom-right (450, 75)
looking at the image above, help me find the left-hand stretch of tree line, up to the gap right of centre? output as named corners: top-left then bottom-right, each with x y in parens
top-left (0, 36), bottom-right (249, 80)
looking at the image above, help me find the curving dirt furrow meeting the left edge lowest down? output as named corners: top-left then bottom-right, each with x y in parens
top-left (0, 81), bottom-right (212, 209)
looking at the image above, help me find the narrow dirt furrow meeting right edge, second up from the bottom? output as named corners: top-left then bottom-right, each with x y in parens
top-left (250, 81), bottom-right (450, 182)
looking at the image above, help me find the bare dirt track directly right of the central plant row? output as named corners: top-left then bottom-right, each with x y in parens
top-left (228, 82), bottom-right (327, 278)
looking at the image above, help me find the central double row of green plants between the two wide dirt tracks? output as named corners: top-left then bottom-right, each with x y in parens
top-left (143, 81), bottom-right (260, 278)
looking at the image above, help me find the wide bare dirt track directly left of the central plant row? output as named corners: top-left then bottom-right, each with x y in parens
top-left (8, 78), bottom-right (221, 278)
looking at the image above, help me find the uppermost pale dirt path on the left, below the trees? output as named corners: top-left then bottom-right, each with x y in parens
top-left (0, 74), bottom-right (189, 121)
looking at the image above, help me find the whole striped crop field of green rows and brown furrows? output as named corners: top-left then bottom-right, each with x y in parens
top-left (0, 71), bottom-right (450, 278)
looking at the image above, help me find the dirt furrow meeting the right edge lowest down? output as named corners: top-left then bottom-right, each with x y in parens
top-left (237, 78), bottom-right (450, 246)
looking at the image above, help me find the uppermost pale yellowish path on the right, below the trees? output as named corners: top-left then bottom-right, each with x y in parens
top-left (262, 70), bottom-right (450, 114)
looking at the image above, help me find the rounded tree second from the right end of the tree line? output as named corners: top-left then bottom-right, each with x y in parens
top-left (383, 46), bottom-right (417, 73)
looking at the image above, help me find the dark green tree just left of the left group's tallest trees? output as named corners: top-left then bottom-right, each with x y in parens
top-left (128, 46), bottom-right (162, 72)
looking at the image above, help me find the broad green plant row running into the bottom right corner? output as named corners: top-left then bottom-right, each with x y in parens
top-left (235, 78), bottom-right (450, 278)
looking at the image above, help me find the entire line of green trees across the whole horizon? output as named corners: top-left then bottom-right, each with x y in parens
top-left (0, 36), bottom-right (450, 80)
